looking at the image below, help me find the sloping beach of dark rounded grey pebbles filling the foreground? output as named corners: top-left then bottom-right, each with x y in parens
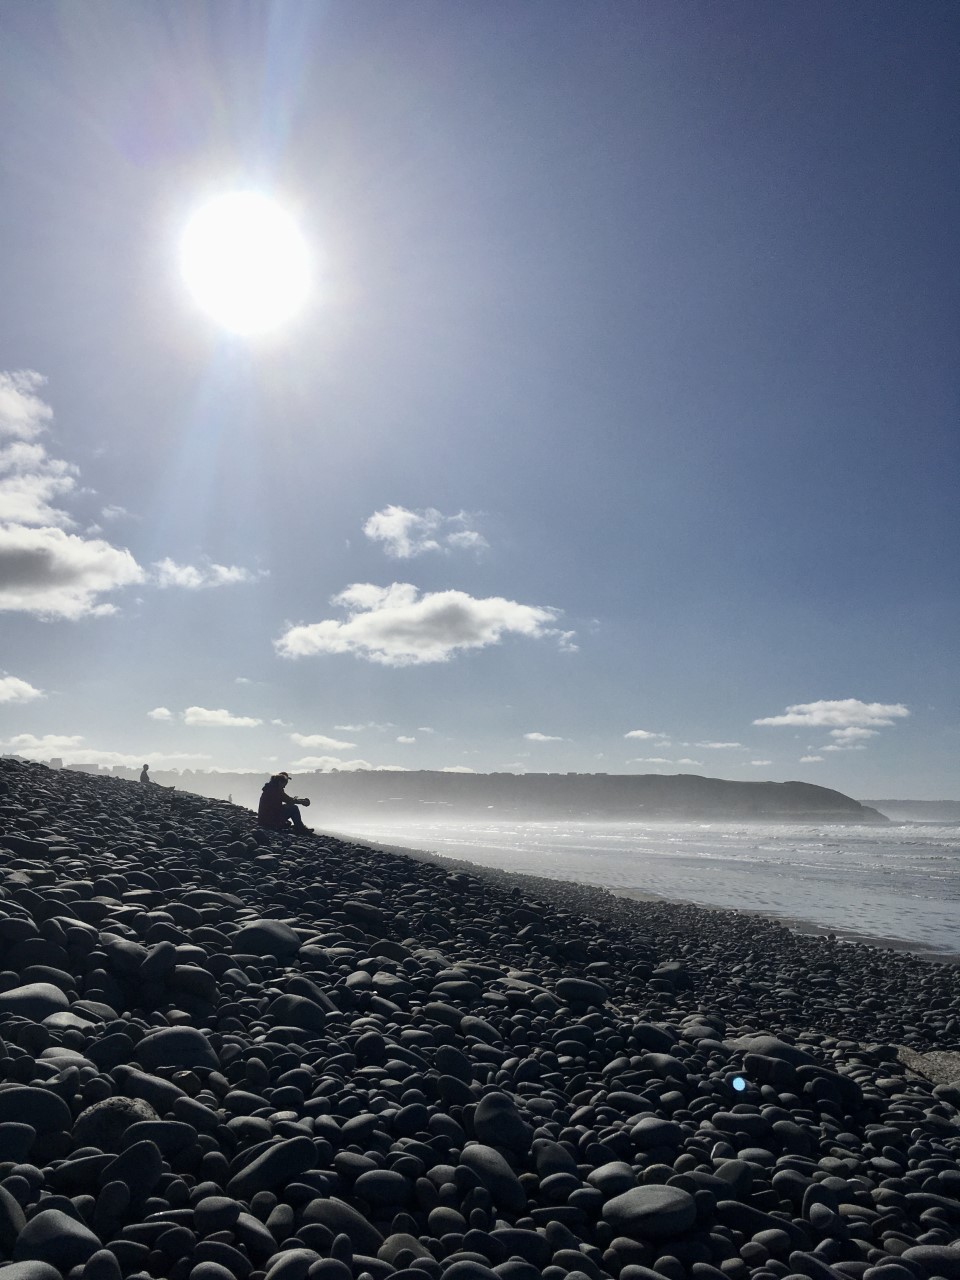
top-left (0, 759), bottom-right (960, 1280)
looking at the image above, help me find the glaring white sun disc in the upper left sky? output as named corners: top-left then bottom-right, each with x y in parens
top-left (180, 191), bottom-right (310, 334)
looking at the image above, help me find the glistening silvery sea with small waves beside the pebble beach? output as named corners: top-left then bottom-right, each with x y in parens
top-left (320, 819), bottom-right (960, 959)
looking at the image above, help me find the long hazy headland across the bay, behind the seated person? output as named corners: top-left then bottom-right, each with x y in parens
top-left (69, 769), bottom-right (886, 826)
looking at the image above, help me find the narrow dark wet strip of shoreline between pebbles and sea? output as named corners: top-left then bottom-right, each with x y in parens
top-left (330, 831), bottom-right (960, 965)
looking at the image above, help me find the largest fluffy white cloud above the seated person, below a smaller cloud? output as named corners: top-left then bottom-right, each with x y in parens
top-left (274, 582), bottom-right (568, 667)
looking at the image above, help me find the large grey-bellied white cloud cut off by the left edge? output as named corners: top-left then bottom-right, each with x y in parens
top-left (0, 524), bottom-right (143, 620)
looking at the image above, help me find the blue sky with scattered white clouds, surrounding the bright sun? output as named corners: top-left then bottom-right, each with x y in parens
top-left (0, 0), bottom-right (960, 797)
